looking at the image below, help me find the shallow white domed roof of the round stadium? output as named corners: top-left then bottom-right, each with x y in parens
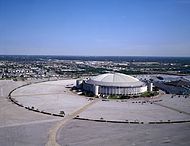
top-left (87, 73), bottom-right (144, 87)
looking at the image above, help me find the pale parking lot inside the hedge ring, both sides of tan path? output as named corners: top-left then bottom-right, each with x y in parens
top-left (12, 80), bottom-right (190, 123)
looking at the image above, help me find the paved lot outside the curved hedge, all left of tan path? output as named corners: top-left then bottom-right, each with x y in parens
top-left (0, 80), bottom-right (62, 146)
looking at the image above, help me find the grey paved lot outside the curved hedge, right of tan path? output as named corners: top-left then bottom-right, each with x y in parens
top-left (57, 120), bottom-right (190, 146)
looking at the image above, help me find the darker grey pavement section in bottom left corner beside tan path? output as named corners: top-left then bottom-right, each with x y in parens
top-left (0, 121), bottom-right (55, 146)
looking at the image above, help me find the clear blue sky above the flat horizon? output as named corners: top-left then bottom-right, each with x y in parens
top-left (0, 0), bottom-right (190, 56)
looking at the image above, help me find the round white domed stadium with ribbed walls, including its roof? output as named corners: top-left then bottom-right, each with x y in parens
top-left (77, 73), bottom-right (147, 96)
